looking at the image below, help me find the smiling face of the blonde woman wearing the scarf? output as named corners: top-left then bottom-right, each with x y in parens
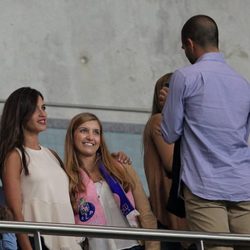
top-left (73, 120), bottom-right (101, 157)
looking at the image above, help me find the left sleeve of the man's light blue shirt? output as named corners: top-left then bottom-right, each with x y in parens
top-left (161, 71), bottom-right (185, 143)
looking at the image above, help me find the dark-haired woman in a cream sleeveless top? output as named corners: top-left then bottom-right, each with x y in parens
top-left (0, 87), bottom-right (81, 250)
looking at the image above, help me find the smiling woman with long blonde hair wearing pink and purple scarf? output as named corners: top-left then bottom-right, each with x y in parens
top-left (65, 113), bottom-right (159, 250)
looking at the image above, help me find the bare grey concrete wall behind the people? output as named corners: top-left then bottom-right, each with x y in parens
top-left (0, 0), bottom-right (250, 124)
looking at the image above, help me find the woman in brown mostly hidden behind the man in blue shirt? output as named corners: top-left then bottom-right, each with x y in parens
top-left (143, 73), bottom-right (187, 250)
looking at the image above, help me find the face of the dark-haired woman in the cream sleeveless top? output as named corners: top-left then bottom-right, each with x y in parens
top-left (24, 96), bottom-right (47, 134)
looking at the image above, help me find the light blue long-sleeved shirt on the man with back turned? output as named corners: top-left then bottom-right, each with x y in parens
top-left (161, 53), bottom-right (250, 201)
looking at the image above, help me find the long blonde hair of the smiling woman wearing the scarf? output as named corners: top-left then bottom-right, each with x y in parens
top-left (64, 113), bottom-right (133, 212)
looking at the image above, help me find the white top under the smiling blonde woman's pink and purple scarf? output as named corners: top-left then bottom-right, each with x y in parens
top-left (89, 181), bottom-right (139, 250)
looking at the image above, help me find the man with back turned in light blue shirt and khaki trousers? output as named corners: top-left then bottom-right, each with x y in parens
top-left (161, 15), bottom-right (250, 250)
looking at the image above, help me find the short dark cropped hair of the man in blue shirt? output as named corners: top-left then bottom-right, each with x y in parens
top-left (181, 15), bottom-right (219, 48)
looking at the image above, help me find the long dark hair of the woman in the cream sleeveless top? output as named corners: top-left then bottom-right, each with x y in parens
top-left (0, 87), bottom-right (43, 177)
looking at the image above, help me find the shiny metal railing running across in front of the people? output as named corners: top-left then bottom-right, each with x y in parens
top-left (0, 221), bottom-right (250, 250)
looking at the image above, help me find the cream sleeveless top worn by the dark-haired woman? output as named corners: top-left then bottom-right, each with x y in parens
top-left (19, 146), bottom-right (81, 250)
